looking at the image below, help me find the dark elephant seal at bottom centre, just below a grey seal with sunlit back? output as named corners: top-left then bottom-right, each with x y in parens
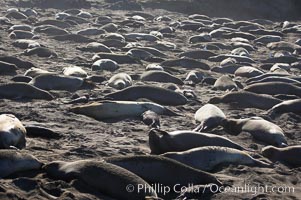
top-left (104, 155), bottom-right (221, 186)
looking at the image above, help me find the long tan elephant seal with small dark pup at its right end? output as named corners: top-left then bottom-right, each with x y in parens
top-left (70, 101), bottom-right (177, 121)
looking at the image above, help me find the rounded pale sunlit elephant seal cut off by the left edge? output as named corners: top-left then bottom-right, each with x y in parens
top-left (0, 114), bottom-right (26, 149)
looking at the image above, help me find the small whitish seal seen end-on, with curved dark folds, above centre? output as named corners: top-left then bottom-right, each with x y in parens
top-left (108, 73), bottom-right (133, 90)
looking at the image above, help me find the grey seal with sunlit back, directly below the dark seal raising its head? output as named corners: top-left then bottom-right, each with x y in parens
top-left (162, 146), bottom-right (271, 171)
